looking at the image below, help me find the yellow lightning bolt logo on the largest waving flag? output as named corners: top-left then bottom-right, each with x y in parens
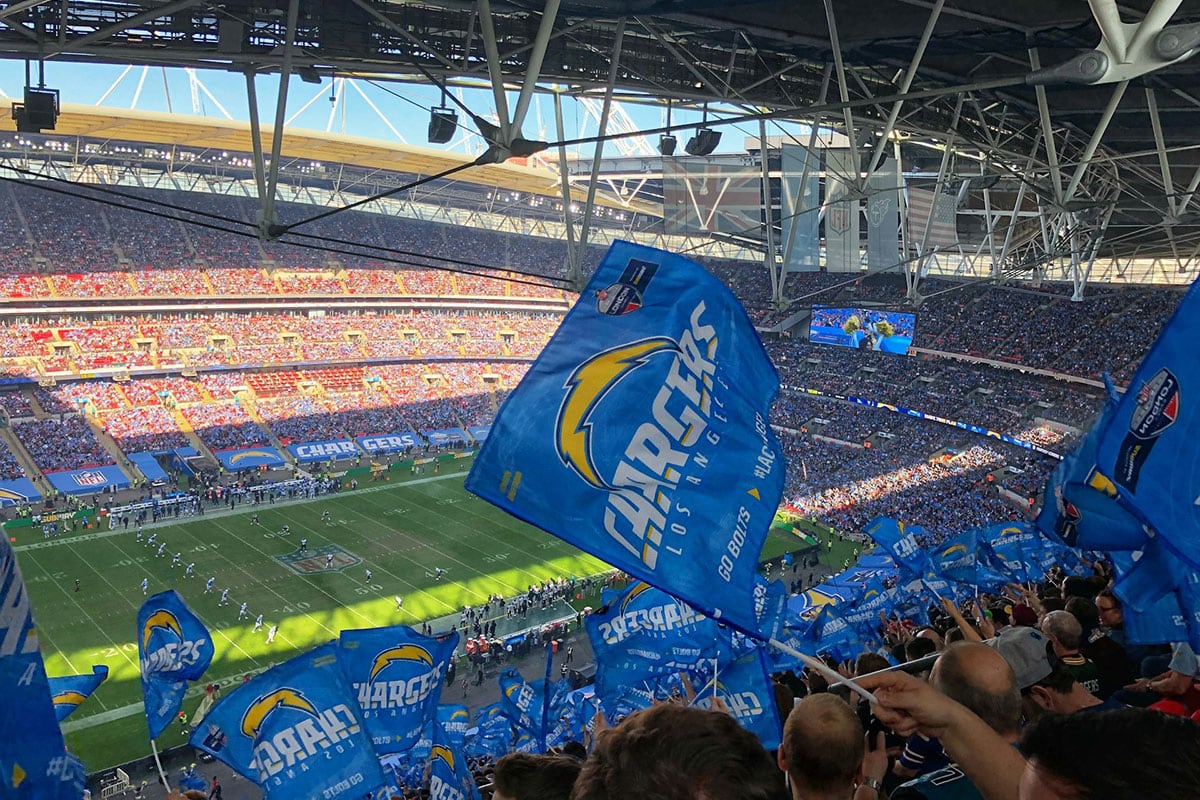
top-left (554, 336), bottom-right (679, 491)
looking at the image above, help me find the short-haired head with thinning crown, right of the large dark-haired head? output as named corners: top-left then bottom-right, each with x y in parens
top-left (778, 694), bottom-right (864, 800)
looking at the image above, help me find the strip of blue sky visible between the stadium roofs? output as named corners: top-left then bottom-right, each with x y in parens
top-left (0, 61), bottom-right (798, 157)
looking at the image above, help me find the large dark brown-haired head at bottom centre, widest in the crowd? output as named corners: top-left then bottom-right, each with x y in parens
top-left (571, 703), bottom-right (787, 800)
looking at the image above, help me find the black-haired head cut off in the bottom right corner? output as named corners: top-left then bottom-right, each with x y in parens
top-left (1020, 709), bottom-right (1200, 800)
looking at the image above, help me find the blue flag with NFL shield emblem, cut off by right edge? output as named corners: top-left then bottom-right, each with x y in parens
top-left (1096, 283), bottom-right (1200, 569)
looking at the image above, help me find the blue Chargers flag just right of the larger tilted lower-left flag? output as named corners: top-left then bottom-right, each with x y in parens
top-left (337, 625), bottom-right (458, 754)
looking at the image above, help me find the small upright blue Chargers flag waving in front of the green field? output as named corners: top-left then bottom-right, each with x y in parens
top-left (138, 589), bottom-right (214, 739)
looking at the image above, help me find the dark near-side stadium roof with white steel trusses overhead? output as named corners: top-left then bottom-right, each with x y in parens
top-left (0, 0), bottom-right (1200, 287)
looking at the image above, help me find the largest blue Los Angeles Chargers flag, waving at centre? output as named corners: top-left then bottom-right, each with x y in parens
top-left (467, 242), bottom-right (784, 638)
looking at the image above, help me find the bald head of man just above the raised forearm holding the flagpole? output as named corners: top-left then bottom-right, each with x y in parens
top-left (929, 642), bottom-right (1021, 736)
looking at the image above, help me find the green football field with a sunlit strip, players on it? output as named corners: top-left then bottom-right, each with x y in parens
top-left (16, 461), bottom-right (835, 771)
